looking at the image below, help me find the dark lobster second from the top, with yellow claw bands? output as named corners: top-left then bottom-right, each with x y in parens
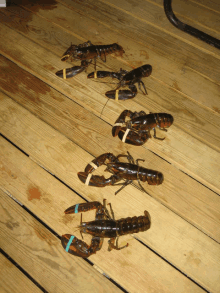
top-left (87, 64), bottom-right (152, 100)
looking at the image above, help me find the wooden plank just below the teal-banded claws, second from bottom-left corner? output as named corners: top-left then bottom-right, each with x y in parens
top-left (0, 190), bottom-right (121, 292)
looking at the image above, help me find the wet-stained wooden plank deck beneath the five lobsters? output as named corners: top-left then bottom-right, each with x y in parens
top-left (0, 0), bottom-right (220, 293)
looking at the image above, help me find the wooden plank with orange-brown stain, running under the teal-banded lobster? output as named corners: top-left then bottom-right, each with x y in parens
top-left (0, 138), bottom-right (208, 292)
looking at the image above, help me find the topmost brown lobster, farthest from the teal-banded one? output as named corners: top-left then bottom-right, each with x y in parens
top-left (56, 41), bottom-right (124, 79)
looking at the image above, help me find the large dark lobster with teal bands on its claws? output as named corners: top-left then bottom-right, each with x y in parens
top-left (61, 199), bottom-right (151, 258)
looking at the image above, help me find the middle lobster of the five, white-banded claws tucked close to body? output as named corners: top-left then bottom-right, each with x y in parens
top-left (112, 110), bottom-right (173, 146)
